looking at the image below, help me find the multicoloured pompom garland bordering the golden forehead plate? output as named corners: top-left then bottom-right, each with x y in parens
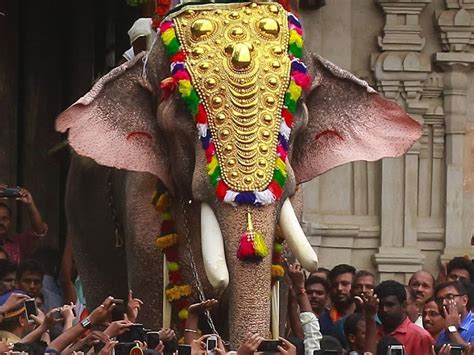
top-left (160, 12), bottom-right (311, 206)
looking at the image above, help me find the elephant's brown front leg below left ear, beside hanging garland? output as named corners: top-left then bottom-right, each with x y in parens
top-left (124, 172), bottom-right (163, 329)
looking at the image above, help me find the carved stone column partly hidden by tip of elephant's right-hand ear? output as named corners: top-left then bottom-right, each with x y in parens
top-left (371, 0), bottom-right (431, 281)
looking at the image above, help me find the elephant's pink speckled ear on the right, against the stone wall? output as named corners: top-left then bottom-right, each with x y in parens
top-left (292, 56), bottom-right (422, 183)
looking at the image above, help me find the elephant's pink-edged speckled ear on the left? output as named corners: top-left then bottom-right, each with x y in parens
top-left (56, 54), bottom-right (170, 186)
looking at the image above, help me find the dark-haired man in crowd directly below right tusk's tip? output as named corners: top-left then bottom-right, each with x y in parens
top-left (305, 276), bottom-right (333, 335)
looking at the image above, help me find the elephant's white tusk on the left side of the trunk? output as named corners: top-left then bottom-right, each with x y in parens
top-left (201, 203), bottom-right (229, 290)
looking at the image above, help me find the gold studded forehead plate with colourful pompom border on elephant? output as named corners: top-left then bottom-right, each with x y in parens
top-left (160, 3), bottom-right (312, 204)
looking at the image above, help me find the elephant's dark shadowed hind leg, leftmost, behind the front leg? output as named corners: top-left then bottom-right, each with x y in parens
top-left (66, 155), bottom-right (127, 310)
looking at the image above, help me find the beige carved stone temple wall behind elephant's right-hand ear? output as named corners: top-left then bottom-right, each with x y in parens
top-left (300, 0), bottom-right (474, 281)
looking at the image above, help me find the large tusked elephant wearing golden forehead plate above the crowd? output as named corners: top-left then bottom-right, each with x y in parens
top-left (56, 3), bottom-right (421, 348)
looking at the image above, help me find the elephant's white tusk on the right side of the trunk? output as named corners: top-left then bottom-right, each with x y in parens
top-left (280, 199), bottom-right (318, 272)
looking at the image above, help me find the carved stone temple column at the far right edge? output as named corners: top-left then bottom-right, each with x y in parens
top-left (435, 0), bottom-right (474, 261)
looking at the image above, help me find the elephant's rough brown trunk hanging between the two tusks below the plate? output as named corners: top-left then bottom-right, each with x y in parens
top-left (214, 204), bottom-right (277, 349)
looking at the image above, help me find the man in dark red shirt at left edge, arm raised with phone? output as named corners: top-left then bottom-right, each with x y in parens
top-left (0, 185), bottom-right (48, 264)
